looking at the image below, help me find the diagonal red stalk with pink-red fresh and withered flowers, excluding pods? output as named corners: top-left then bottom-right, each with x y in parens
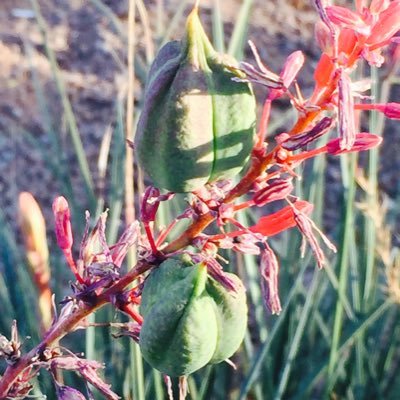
top-left (0, 0), bottom-right (400, 399)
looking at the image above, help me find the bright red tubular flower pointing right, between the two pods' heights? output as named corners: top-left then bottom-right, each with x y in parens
top-left (249, 200), bottom-right (314, 236)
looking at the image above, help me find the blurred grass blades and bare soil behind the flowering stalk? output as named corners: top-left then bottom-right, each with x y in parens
top-left (0, 0), bottom-right (400, 400)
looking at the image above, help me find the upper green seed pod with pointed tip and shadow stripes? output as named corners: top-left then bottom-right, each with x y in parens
top-left (135, 9), bottom-right (255, 192)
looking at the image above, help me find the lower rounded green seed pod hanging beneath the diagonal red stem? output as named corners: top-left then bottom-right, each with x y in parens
top-left (139, 259), bottom-right (247, 376)
